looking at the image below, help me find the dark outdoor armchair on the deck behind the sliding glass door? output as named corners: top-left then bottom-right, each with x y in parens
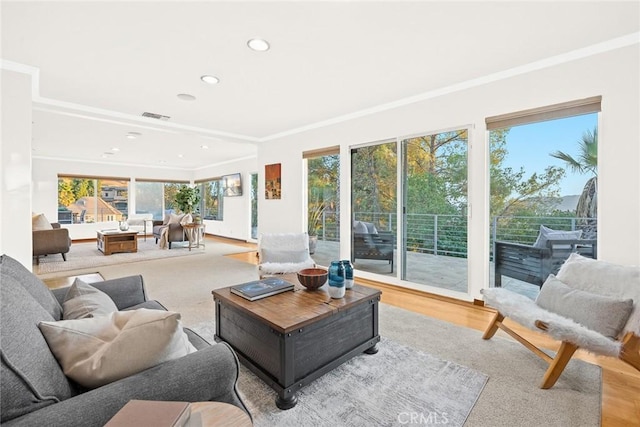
top-left (351, 221), bottom-right (395, 273)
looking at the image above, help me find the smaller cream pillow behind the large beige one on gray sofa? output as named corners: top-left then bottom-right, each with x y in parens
top-left (62, 278), bottom-right (118, 320)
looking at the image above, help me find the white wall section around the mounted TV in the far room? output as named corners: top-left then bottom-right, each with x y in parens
top-left (194, 157), bottom-right (258, 240)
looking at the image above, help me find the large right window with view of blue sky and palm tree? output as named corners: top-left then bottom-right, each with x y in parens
top-left (489, 112), bottom-right (598, 298)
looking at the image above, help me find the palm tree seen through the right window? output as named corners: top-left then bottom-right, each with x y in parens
top-left (551, 128), bottom-right (598, 237)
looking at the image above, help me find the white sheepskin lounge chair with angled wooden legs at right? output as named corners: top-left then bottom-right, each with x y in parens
top-left (482, 253), bottom-right (640, 389)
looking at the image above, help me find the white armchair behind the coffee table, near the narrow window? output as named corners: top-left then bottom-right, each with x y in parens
top-left (258, 233), bottom-right (315, 277)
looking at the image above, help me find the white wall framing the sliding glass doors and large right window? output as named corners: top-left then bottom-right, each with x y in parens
top-left (258, 45), bottom-right (640, 297)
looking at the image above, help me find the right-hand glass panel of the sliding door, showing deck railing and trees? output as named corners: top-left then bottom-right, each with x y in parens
top-left (401, 129), bottom-right (468, 292)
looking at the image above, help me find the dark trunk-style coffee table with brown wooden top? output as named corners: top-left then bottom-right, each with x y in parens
top-left (212, 284), bottom-right (381, 409)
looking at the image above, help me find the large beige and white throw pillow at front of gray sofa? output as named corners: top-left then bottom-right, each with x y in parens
top-left (38, 308), bottom-right (196, 388)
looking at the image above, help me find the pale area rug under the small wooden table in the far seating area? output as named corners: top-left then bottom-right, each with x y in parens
top-left (33, 238), bottom-right (248, 275)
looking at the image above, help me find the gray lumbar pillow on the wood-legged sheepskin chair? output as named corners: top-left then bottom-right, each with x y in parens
top-left (536, 274), bottom-right (633, 339)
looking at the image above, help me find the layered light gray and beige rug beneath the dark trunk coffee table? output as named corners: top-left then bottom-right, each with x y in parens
top-left (193, 304), bottom-right (601, 427)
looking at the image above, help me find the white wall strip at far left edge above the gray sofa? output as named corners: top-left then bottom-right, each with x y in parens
top-left (0, 70), bottom-right (33, 270)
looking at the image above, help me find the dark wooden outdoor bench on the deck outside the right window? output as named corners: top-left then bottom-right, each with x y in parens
top-left (493, 239), bottom-right (597, 287)
